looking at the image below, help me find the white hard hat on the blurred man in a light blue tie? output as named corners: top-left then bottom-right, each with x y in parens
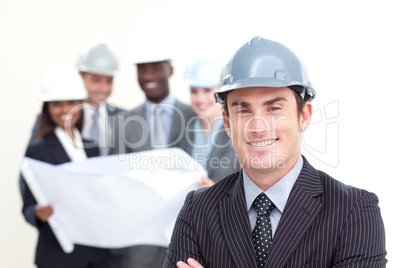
top-left (130, 33), bottom-right (173, 64)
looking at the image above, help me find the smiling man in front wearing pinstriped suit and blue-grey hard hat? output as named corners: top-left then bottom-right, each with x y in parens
top-left (163, 37), bottom-right (387, 268)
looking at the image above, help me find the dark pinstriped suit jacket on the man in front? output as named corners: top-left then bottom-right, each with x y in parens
top-left (163, 156), bottom-right (386, 268)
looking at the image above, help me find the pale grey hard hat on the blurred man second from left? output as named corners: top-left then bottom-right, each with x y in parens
top-left (77, 42), bottom-right (119, 76)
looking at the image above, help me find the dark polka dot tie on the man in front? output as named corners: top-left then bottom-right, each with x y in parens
top-left (253, 193), bottom-right (275, 267)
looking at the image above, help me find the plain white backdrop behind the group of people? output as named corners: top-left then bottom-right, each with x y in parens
top-left (0, 0), bottom-right (402, 268)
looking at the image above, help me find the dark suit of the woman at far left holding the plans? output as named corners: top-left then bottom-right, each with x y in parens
top-left (20, 134), bottom-right (110, 268)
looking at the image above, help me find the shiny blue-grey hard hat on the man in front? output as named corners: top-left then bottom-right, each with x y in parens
top-left (214, 36), bottom-right (316, 104)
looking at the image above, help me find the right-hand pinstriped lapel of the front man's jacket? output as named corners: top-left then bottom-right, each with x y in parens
top-left (265, 158), bottom-right (323, 268)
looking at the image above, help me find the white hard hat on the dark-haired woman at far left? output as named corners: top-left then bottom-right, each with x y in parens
top-left (38, 65), bottom-right (88, 102)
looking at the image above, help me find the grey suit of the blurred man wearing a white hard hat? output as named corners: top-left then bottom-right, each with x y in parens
top-left (111, 100), bottom-right (194, 268)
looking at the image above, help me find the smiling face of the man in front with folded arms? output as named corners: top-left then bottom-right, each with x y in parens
top-left (223, 87), bottom-right (311, 176)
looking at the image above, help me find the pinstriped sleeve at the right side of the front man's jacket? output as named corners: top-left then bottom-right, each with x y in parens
top-left (333, 192), bottom-right (386, 267)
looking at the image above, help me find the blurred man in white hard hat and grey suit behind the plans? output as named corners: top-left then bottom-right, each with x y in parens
top-left (111, 36), bottom-right (194, 268)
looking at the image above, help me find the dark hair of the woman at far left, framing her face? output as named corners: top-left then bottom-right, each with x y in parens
top-left (35, 102), bottom-right (84, 140)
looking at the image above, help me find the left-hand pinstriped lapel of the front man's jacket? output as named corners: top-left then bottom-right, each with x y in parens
top-left (219, 172), bottom-right (257, 268)
